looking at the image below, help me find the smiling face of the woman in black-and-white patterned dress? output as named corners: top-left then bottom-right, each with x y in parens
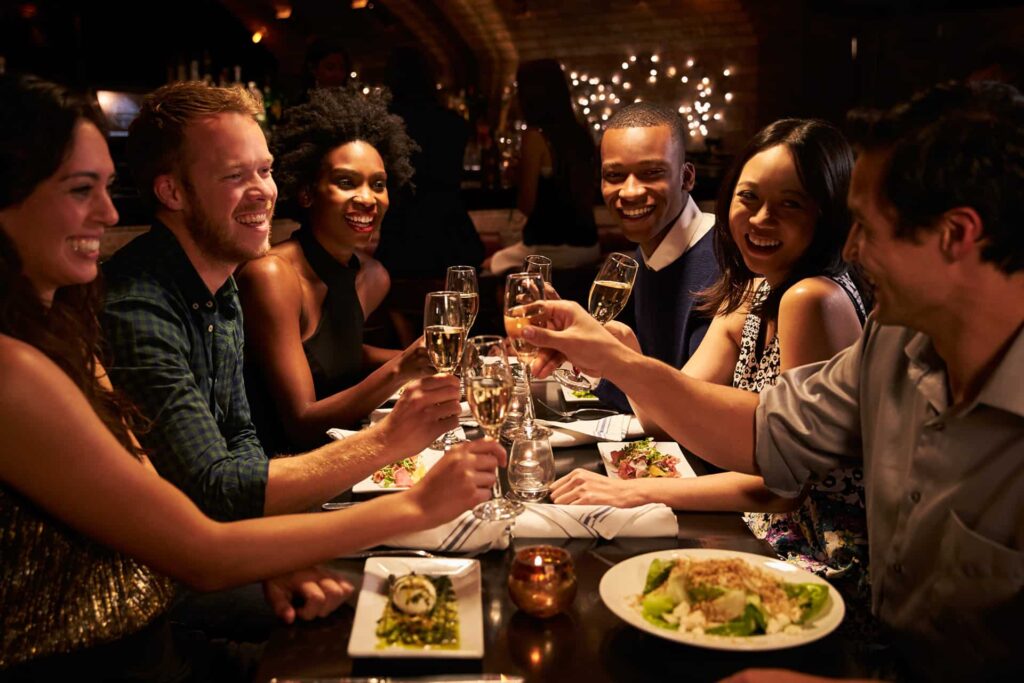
top-left (729, 144), bottom-right (820, 286)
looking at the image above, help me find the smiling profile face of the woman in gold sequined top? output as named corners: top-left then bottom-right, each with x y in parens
top-left (0, 121), bottom-right (118, 302)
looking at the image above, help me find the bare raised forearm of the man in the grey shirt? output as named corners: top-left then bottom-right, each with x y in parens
top-left (604, 351), bottom-right (758, 474)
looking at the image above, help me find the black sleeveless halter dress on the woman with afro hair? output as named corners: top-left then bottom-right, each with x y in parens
top-left (246, 228), bottom-right (366, 456)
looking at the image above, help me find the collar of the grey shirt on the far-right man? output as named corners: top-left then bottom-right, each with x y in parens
top-left (903, 327), bottom-right (1024, 417)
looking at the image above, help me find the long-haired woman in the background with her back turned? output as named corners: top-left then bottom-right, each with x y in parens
top-left (489, 59), bottom-right (600, 272)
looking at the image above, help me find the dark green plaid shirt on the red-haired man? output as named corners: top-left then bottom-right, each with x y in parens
top-left (101, 223), bottom-right (268, 520)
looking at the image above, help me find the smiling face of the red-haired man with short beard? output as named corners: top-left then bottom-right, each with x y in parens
top-left (181, 114), bottom-right (278, 264)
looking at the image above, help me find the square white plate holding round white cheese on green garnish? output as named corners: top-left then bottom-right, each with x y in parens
top-left (348, 557), bottom-right (483, 659)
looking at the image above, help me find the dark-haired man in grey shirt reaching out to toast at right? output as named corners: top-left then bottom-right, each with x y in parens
top-left (525, 83), bottom-right (1024, 680)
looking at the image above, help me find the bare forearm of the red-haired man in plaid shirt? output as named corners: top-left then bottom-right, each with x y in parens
top-left (263, 426), bottom-right (391, 515)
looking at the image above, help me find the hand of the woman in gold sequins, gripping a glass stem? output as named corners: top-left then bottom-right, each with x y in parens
top-left (409, 438), bottom-right (507, 526)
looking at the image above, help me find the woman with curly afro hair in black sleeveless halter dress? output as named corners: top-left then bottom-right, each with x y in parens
top-left (239, 89), bottom-right (433, 454)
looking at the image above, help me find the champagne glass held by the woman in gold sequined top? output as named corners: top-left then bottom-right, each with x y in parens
top-left (462, 335), bottom-right (523, 519)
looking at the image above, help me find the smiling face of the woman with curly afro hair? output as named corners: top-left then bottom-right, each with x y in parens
top-left (305, 140), bottom-right (388, 250)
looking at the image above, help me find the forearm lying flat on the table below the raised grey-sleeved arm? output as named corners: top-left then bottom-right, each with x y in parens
top-left (635, 472), bottom-right (800, 512)
